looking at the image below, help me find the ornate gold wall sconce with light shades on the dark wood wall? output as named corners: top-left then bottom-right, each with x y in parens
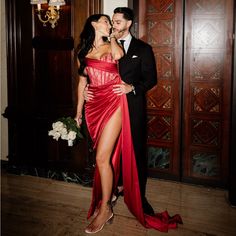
top-left (30, 0), bottom-right (66, 29)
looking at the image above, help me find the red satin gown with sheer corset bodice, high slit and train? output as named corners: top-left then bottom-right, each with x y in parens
top-left (85, 54), bottom-right (182, 232)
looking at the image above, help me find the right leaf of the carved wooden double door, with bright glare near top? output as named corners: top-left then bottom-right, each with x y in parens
top-left (183, 0), bottom-right (233, 186)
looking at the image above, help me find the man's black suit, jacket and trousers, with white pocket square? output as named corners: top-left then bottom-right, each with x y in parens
top-left (119, 37), bottom-right (157, 196)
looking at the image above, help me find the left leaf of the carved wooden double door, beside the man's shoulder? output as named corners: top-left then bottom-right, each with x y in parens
top-left (139, 0), bottom-right (183, 179)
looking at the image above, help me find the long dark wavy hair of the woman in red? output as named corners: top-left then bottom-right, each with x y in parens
top-left (77, 14), bottom-right (111, 75)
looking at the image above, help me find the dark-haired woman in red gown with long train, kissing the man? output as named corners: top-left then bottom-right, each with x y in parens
top-left (75, 14), bottom-right (182, 233)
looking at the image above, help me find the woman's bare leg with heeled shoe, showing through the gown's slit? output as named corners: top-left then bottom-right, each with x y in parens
top-left (86, 108), bottom-right (121, 232)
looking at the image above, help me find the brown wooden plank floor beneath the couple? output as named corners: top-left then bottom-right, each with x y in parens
top-left (1, 173), bottom-right (236, 236)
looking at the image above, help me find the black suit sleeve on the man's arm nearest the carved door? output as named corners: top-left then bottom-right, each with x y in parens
top-left (134, 44), bottom-right (157, 95)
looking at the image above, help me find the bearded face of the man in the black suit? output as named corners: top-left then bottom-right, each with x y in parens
top-left (112, 13), bottom-right (132, 38)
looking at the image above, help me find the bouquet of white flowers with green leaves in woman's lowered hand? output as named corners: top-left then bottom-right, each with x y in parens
top-left (48, 117), bottom-right (83, 146)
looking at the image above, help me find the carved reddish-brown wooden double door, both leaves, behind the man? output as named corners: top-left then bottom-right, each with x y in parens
top-left (138, 0), bottom-right (233, 186)
